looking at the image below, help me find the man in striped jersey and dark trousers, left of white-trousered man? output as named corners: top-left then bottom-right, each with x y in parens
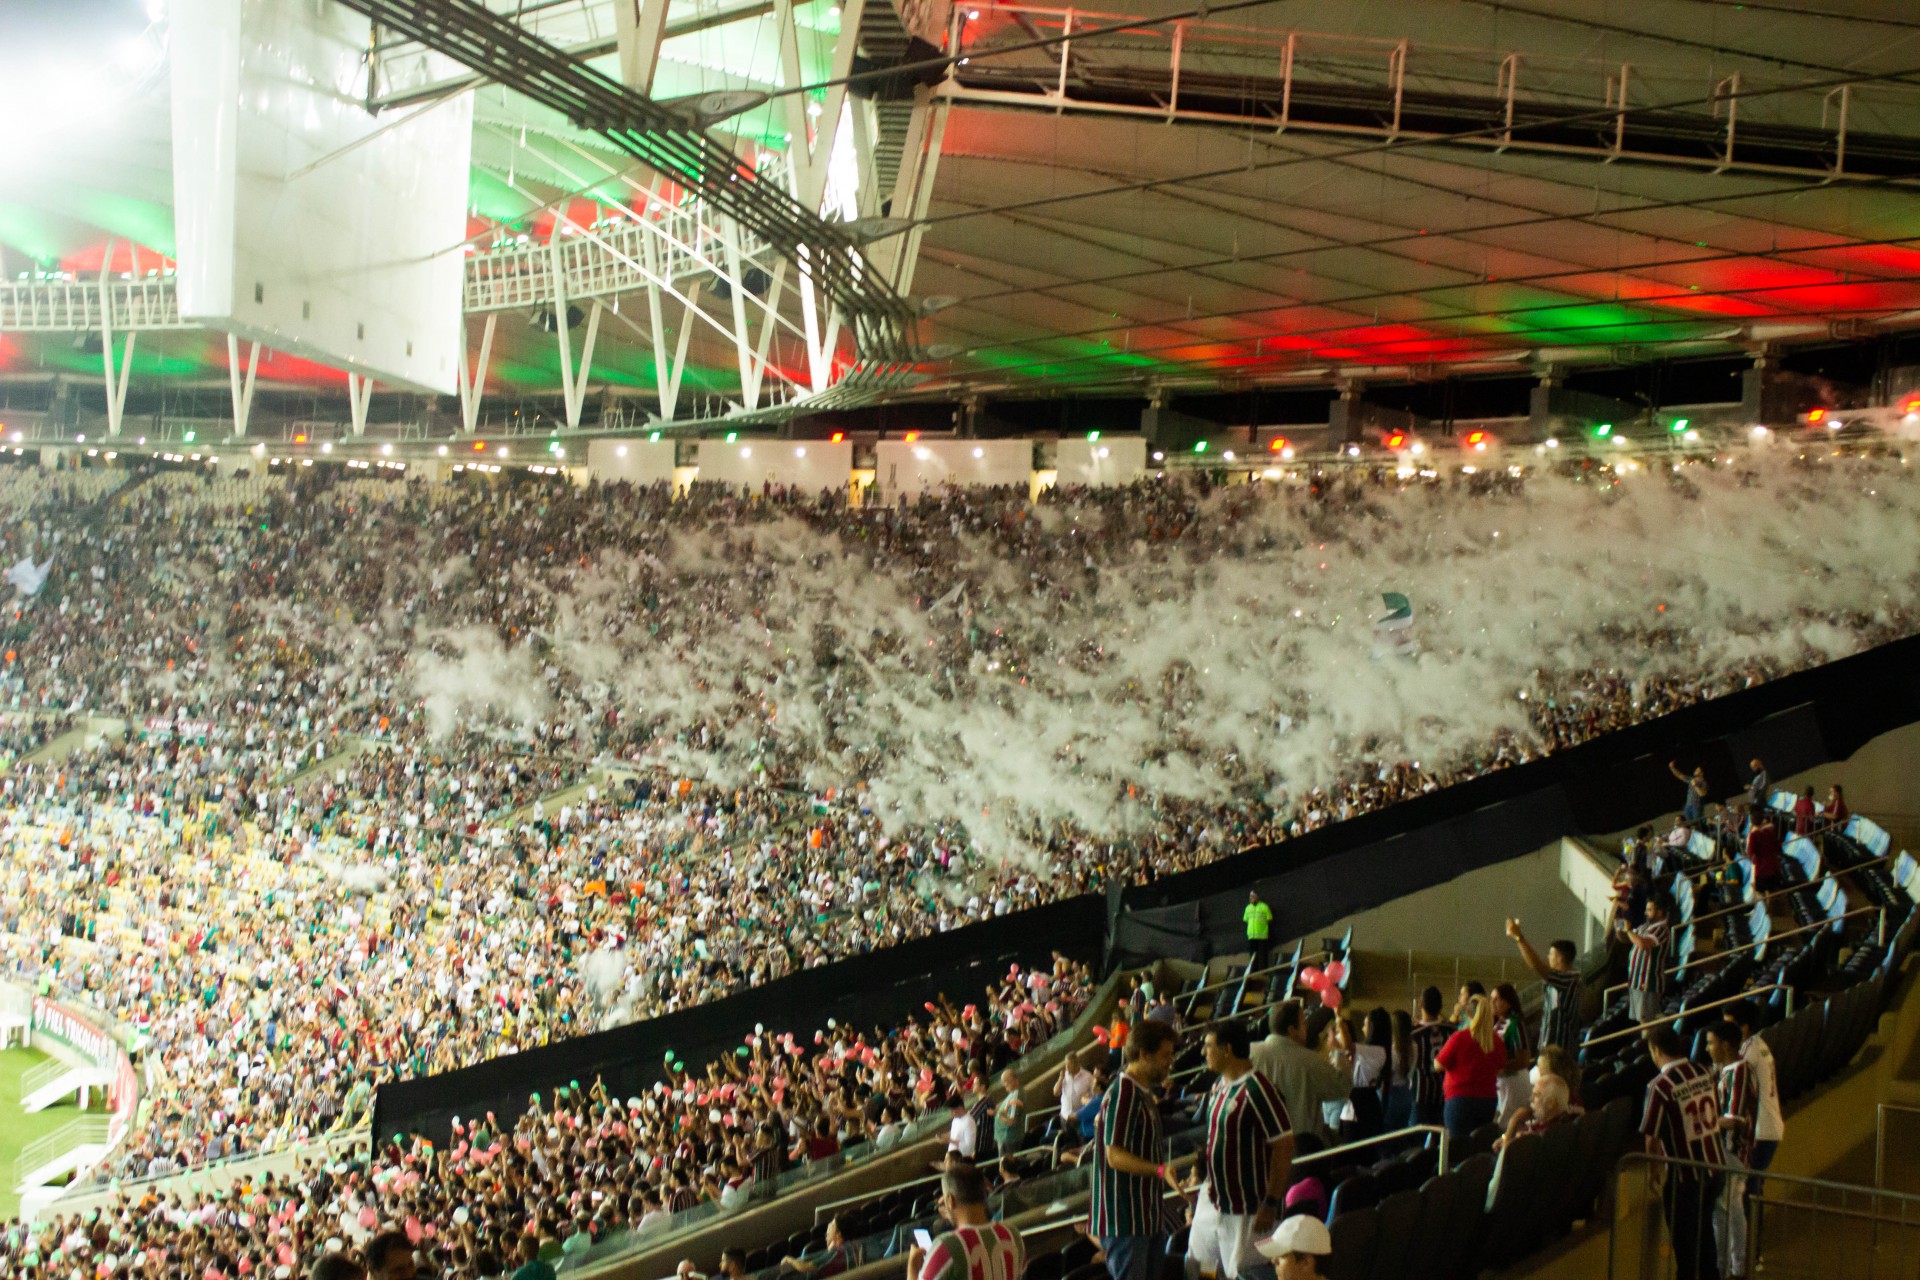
top-left (1087, 1021), bottom-right (1181, 1280)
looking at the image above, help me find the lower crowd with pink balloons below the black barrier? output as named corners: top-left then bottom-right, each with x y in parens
top-left (0, 956), bottom-right (1092, 1280)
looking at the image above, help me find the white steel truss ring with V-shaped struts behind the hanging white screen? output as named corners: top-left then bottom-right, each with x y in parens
top-left (0, 0), bottom-right (948, 436)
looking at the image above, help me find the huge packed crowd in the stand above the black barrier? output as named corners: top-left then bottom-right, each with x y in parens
top-left (0, 450), bottom-right (1920, 1274)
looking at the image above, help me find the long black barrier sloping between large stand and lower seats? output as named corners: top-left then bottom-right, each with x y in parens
top-left (374, 637), bottom-right (1920, 1142)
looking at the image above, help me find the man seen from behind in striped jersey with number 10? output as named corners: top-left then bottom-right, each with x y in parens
top-left (1640, 1025), bottom-right (1724, 1280)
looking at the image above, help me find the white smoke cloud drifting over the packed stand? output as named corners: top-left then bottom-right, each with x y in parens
top-left (415, 457), bottom-right (1920, 856)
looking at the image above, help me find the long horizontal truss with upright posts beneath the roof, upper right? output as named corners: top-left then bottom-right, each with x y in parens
top-left (939, 0), bottom-right (1920, 184)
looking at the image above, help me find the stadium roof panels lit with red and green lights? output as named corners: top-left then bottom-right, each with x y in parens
top-left (0, 0), bottom-right (1920, 416)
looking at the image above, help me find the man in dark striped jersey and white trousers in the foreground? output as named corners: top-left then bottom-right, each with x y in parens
top-left (1187, 1023), bottom-right (1294, 1280)
